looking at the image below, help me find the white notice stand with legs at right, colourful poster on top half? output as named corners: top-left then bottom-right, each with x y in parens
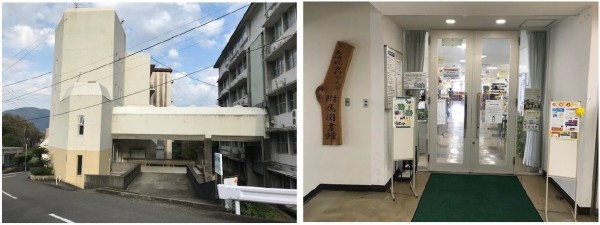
top-left (544, 101), bottom-right (580, 222)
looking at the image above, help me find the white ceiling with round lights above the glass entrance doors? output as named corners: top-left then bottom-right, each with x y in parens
top-left (371, 2), bottom-right (598, 30)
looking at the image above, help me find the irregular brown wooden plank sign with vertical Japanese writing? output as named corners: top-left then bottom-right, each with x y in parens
top-left (315, 41), bottom-right (354, 145)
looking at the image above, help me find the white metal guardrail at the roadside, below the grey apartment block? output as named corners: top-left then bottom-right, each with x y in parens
top-left (217, 184), bottom-right (298, 215)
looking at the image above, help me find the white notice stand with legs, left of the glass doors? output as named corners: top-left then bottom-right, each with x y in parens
top-left (390, 97), bottom-right (419, 201)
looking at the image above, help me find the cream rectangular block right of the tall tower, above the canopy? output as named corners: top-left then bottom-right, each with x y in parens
top-left (124, 53), bottom-right (150, 106)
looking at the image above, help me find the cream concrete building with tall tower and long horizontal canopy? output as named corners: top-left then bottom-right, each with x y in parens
top-left (48, 8), bottom-right (266, 188)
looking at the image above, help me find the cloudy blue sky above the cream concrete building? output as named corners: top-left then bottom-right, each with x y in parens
top-left (2, 2), bottom-right (249, 111)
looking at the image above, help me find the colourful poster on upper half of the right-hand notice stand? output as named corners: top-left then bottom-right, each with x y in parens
top-left (550, 101), bottom-right (580, 140)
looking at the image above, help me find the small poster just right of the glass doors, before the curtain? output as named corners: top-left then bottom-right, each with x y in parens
top-left (523, 88), bottom-right (542, 131)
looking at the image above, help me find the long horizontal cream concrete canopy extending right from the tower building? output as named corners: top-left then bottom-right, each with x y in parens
top-left (112, 106), bottom-right (266, 140)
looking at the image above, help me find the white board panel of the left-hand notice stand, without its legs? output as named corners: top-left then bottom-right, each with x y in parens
top-left (392, 97), bottom-right (417, 160)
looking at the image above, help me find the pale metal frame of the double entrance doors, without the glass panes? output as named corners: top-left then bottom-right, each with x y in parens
top-left (428, 30), bottom-right (520, 174)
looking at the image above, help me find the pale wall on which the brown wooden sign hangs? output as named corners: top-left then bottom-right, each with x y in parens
top-left (303, 3), bottom-right (402, 195)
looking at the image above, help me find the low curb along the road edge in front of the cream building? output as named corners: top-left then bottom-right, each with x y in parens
top-left (96, 188), bottom-right (296, 223)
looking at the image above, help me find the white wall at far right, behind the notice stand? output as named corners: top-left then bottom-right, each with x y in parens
top-left (543, 7), bottom-right (598, 207)
